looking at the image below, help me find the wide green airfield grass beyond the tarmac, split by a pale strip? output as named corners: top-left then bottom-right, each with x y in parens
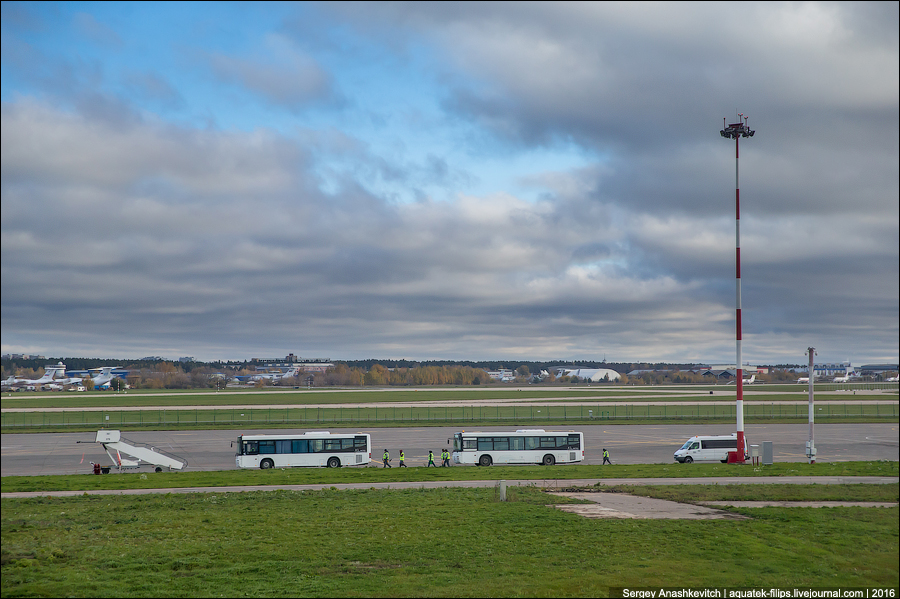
top-left (2, 387), bottom-right (900, 433)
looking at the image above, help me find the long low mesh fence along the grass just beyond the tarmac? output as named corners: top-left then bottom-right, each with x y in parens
top-left (2, 402), bottom-right (898, 431)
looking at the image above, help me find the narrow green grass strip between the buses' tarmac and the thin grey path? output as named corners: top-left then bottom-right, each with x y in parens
top-left (0, 461), bottom-right (900, 493)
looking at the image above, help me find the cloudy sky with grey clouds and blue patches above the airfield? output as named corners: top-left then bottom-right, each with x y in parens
top-left (2, 2), bottom-right (900, 364)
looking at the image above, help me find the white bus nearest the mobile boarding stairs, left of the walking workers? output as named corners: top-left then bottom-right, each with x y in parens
top-left (234, 431), bottom-right (372, 470)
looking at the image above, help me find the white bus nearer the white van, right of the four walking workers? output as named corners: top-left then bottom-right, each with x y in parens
top-left (453, 429), bottom-right (584, 466)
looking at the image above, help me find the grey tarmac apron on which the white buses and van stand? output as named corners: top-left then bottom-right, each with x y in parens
top-left (0, 424), bottom-right (900, 476)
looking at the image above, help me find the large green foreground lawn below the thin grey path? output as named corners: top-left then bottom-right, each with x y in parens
top-left (0, 488), bottom-right (900, 597)
